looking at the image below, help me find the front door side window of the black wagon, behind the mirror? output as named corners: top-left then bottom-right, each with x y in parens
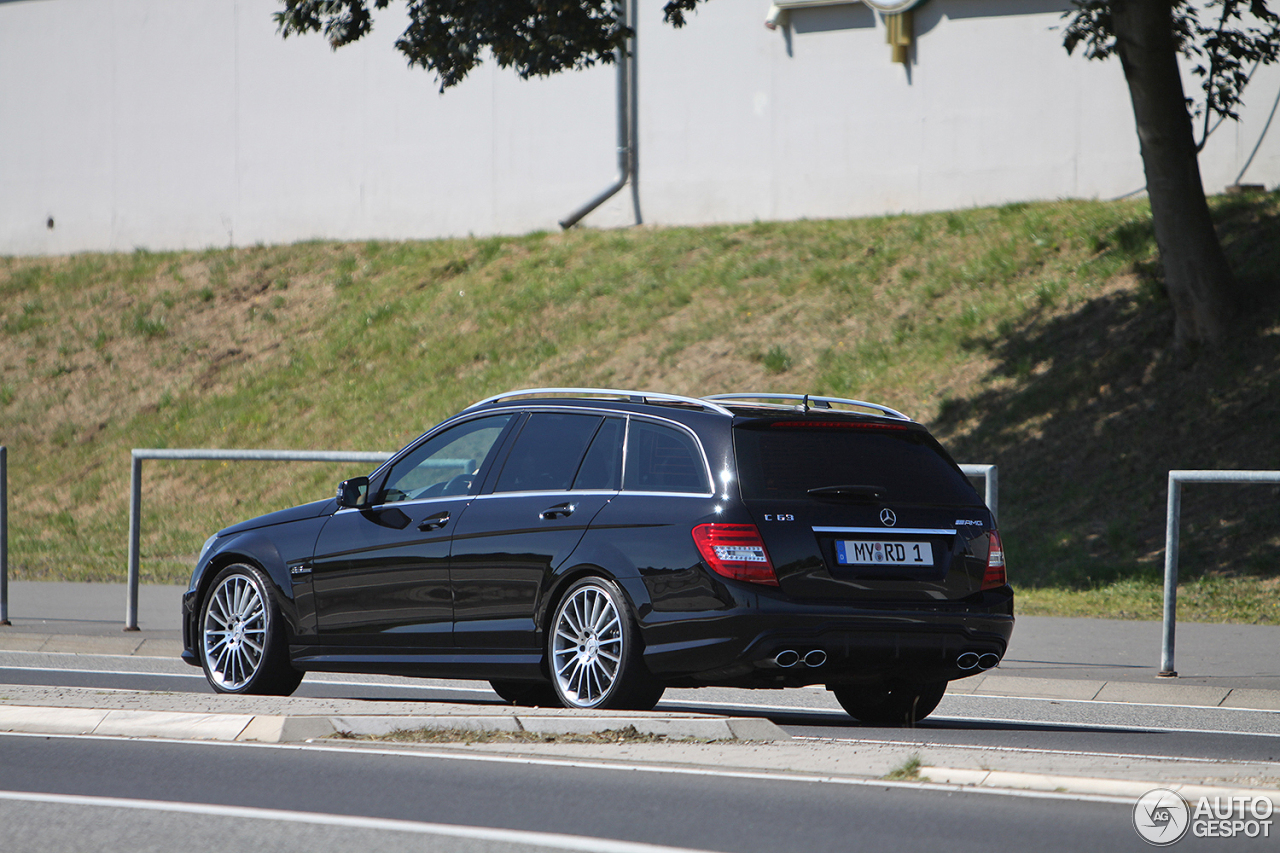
top-left (376, 415), bottom-right (512, 503)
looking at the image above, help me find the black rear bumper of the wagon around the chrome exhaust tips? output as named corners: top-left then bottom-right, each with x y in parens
top-left (643, 592), bottom-right (1014, 686)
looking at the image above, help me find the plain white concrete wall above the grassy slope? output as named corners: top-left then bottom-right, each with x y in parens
top-left (0, 0), bottom-right (1280, 255)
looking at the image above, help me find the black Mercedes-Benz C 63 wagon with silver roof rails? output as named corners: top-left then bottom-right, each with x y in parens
top-left (183, 388), bottom-right (1014, 724)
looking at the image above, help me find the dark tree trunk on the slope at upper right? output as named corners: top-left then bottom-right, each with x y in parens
top-left (1112, 0), bottom-right (1235, 348)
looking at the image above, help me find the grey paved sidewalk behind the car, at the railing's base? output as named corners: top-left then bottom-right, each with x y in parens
top-left (0, 581), bottom-right (1280, 696)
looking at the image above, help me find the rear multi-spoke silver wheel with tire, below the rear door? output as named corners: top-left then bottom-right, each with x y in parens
top-left (548, 578), bottom-right (663, 711)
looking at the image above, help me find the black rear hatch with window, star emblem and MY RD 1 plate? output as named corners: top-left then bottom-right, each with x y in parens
top-left (733, 412), bottom-right (995, 603)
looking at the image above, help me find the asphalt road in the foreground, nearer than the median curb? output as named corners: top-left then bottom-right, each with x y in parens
top-left (0, 735), bottom-right (1228, 853)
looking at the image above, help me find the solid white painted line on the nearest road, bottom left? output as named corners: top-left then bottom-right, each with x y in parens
top-left (0, 790), bottom-right (707, 853)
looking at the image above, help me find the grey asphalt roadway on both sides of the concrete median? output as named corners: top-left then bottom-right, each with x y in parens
top-left (0, 652), bottom-right (1280, 853)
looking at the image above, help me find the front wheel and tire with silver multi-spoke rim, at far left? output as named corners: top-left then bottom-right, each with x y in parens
top-left (197, 564), bottom-right (302, 695)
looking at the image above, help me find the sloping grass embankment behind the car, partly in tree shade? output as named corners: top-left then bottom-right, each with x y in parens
top-left (0, 193), bottom-right (1280, 622)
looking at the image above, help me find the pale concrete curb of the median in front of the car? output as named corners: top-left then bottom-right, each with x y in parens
top-left (0, 704), bottom-right (791, 743)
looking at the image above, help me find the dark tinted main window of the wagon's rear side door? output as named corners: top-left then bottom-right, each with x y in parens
top-left (494, 412), bottom-right (604, 492)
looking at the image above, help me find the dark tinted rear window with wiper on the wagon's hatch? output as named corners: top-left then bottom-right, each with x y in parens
top-left (733, 423), bottom-right (982, 506)
